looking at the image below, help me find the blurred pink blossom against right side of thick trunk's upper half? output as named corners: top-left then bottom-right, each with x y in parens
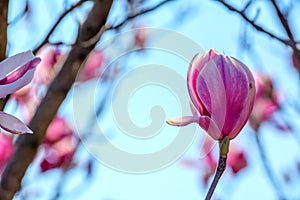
top-left (79, 50), bottom-right (104, 81)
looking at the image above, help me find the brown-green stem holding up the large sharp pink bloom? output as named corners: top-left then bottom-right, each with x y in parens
top-left (205, 137), bottom-right (229, 200)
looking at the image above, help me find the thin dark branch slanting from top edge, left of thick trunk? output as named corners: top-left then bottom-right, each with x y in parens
top-left (33, 0), bottom-right (89, 54)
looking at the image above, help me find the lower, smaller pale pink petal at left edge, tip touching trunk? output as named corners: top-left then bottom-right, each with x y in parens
top-left (0, 111), bottom-right (33, 134)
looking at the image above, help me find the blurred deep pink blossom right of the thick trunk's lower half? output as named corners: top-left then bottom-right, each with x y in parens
top-left (40, 117), bottom-right (78, 172)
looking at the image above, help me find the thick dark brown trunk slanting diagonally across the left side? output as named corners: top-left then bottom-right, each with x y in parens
top-left (0, 0), bottom-right (112, 200)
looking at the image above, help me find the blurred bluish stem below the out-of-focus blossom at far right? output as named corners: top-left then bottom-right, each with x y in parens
top-left (254, 132), bottom-right (286, 199)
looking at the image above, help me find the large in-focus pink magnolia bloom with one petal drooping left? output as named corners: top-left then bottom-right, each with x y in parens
top-left (167, 49), bottom-right (255, 140)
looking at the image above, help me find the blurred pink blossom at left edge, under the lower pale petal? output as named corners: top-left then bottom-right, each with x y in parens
top-left (0, 133), bottom-right (15, 174)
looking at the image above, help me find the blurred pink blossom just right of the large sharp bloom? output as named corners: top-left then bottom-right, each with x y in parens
top-left (249, 74), bottom-right (280, 130)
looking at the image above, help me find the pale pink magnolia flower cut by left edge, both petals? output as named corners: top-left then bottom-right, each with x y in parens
top-left (0, 51), bottom-right (41, 134)
